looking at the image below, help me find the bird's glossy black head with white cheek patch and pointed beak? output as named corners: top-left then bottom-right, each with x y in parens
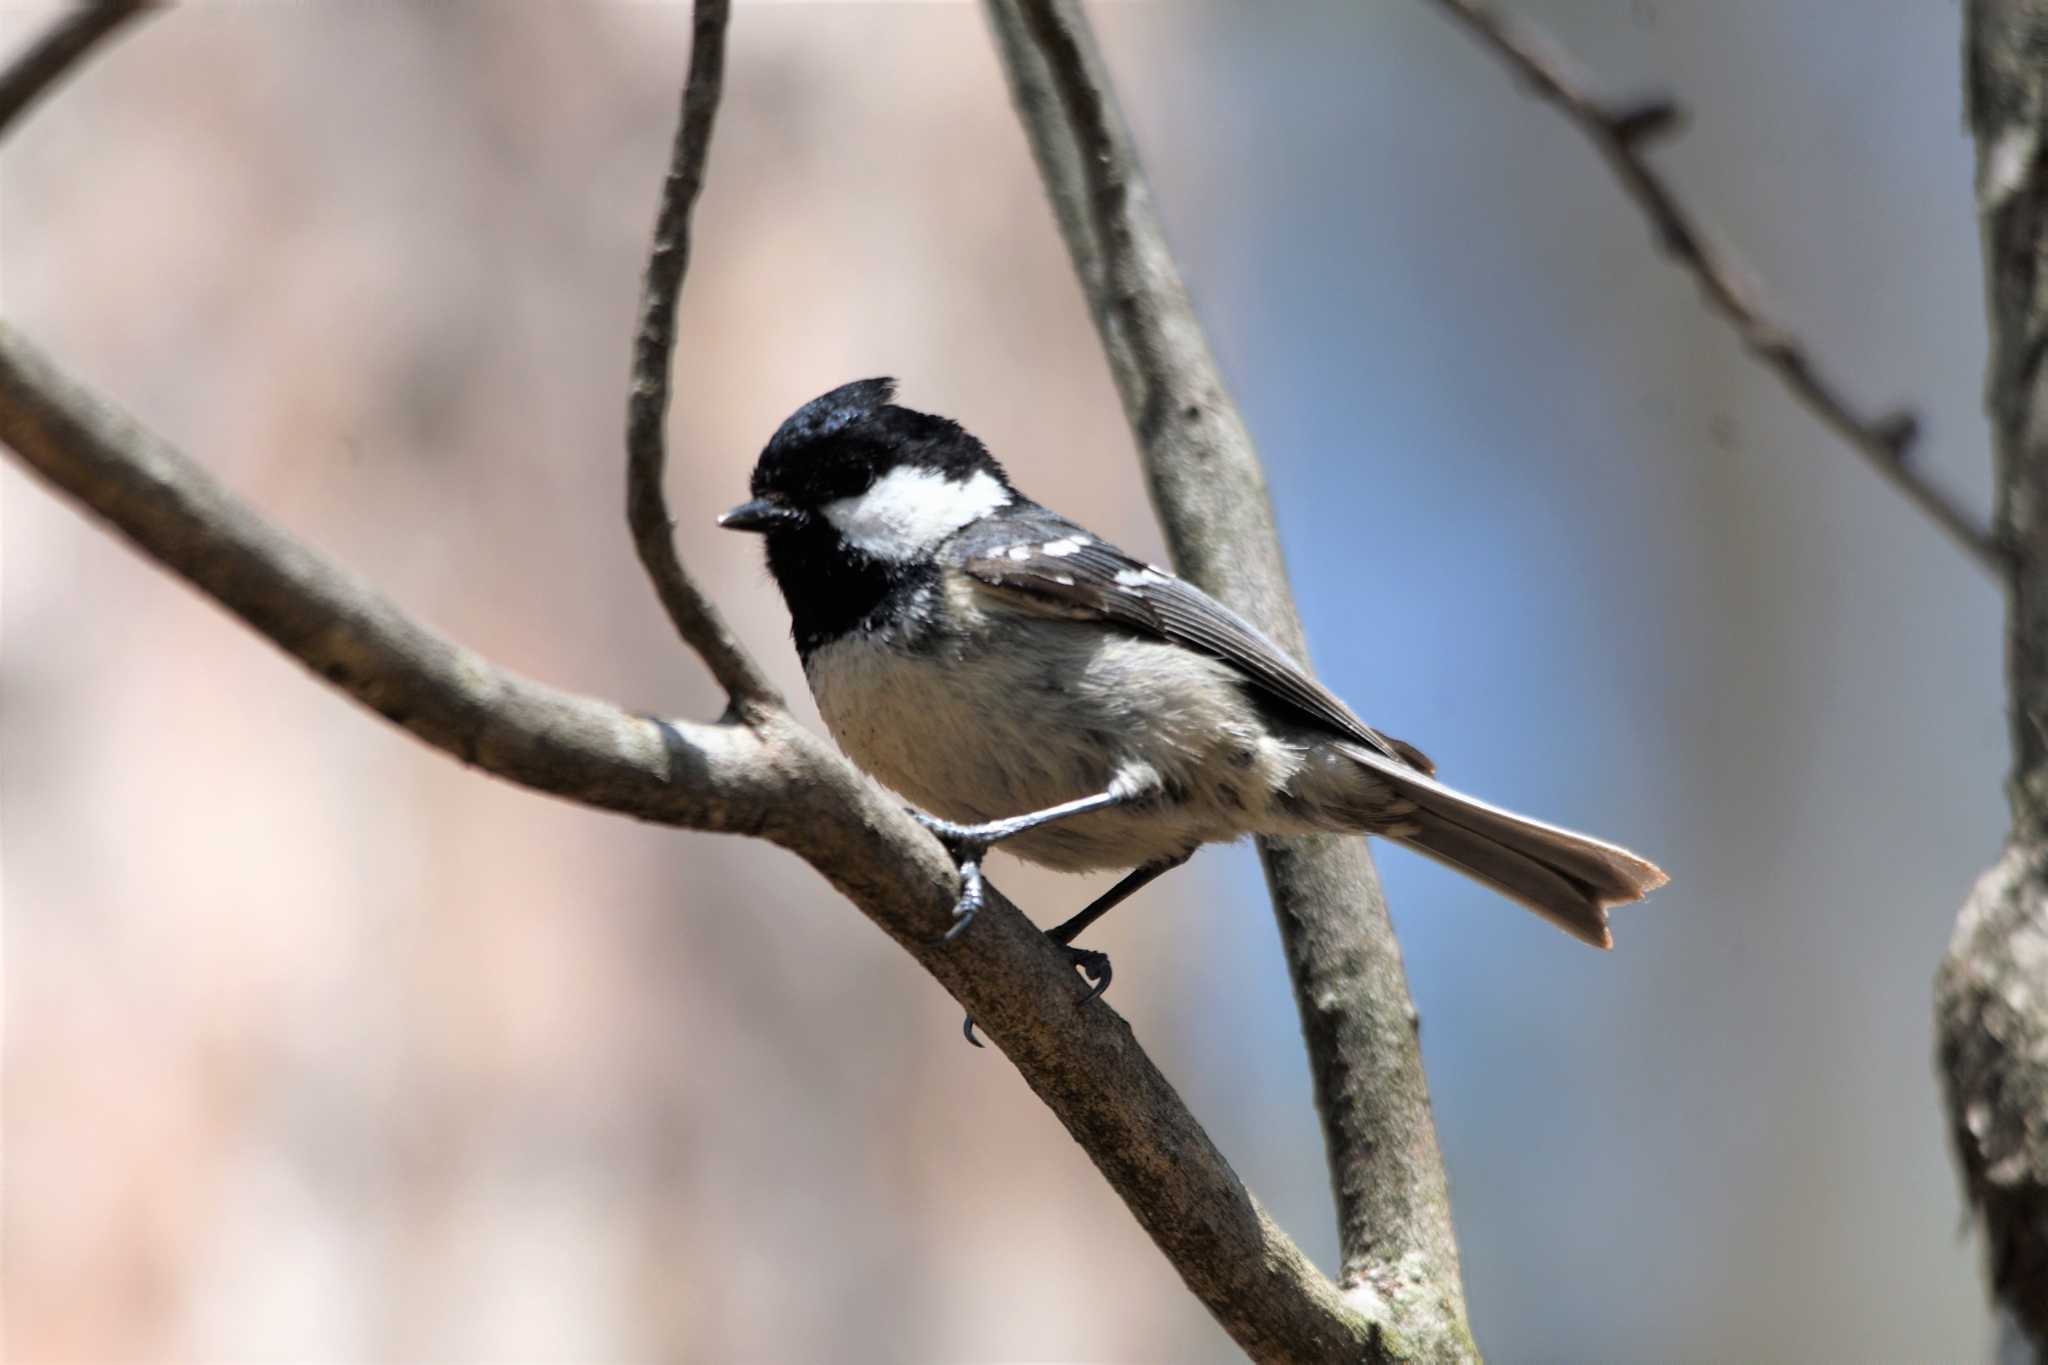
top-left (719, 379), bottom-right (1016, 655)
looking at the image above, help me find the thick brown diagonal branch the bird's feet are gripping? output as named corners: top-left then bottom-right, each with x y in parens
top-left (0, 2), bottom-right (1415, 1361)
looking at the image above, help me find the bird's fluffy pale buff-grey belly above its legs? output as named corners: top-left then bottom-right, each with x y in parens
top-left (805, 620), bottom-right (1300, 872)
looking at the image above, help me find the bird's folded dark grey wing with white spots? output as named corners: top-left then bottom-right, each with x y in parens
top-left (950, 508), bottom-right (1436, 774)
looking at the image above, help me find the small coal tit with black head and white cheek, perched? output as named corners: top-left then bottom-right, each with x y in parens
top-left (719, 379), bottom-right (1665, 993)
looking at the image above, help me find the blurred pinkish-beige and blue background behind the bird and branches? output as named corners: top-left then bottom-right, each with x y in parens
top-left (0, 0), bottom-right (2005, 1363)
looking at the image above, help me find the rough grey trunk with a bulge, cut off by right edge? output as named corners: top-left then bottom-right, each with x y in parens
top-left (1935, 0), bottom-right (2048, 1361)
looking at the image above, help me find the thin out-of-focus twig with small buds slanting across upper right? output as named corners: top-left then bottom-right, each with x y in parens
top-left (1432, 0), bottom-right (2005, 573)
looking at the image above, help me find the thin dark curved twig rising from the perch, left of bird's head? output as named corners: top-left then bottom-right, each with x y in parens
top-left (627, 0), bottom-right (782, 720)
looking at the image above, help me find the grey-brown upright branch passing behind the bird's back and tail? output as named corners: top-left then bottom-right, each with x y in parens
top-left (987, 0), bottom-right (1477, 1359)
